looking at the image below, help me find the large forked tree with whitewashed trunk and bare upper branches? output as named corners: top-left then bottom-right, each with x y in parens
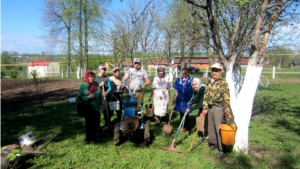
top-left (184, 0), bottom-right (299, 153)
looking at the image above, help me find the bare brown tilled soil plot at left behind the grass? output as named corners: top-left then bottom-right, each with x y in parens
top-left (1, 80), bottom-right (82, 113)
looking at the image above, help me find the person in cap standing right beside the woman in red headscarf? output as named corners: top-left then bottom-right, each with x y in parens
top-left (95, 64), bottom-right (112, 130)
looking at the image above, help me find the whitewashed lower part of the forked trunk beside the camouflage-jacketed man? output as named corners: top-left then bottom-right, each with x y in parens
top-left (226, 65), bottom-right (262, 154)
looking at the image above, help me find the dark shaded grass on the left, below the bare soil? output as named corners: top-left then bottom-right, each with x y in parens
top-left (1, 101), bottom-right (112, 145)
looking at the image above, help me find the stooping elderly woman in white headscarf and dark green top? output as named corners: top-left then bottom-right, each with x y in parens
top-left (185, 78), bottom-right (207, 137)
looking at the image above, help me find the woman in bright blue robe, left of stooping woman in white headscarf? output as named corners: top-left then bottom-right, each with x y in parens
top-left (172, 67), bottom-right (194, 135)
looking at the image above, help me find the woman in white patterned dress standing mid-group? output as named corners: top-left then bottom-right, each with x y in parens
top-left (152, 67), bottom-right (171, 125)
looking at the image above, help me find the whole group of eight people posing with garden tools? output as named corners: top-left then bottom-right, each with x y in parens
top-left (77, 58), bottom-right (231, 158)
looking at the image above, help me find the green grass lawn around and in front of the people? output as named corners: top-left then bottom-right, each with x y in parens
top-left (1, 83), bottom-right (300, 169)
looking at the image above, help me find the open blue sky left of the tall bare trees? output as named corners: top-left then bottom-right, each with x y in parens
top-left (1, 0), bottom-right (48, 54)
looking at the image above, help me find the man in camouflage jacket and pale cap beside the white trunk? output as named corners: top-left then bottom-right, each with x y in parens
top-left (202, 63), bottom-right (231, 158)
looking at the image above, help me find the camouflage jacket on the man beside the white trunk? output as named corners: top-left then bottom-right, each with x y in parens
top-left (203, 76), bottom-right (230, 113)
